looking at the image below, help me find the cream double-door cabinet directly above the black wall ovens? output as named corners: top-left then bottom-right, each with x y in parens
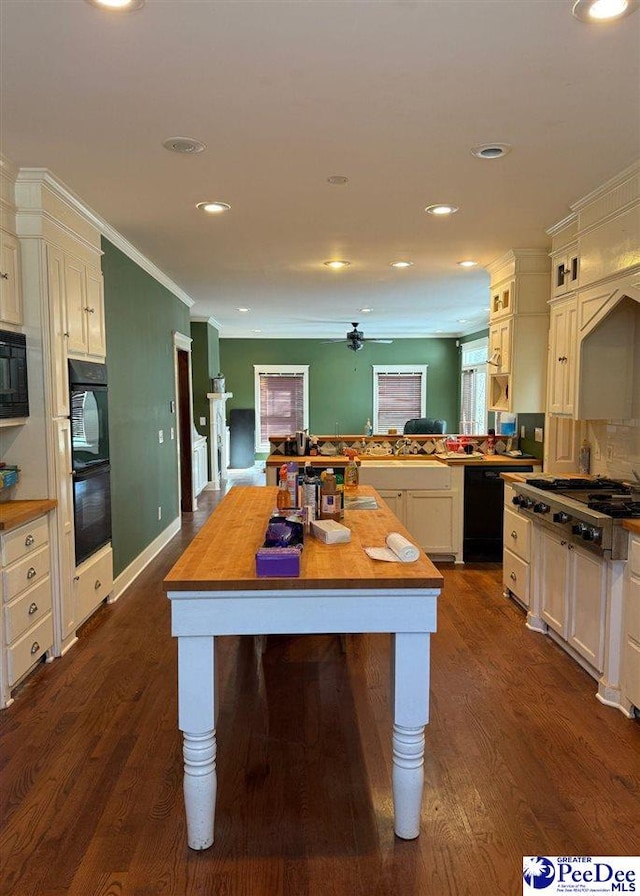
top-left (64, 255), bottom-right (106, 359)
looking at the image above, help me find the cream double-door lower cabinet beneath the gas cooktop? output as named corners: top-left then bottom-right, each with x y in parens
top-left (536, 529), bottom-right (607, 672)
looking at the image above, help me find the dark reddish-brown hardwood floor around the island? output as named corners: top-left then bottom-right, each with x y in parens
top-left (0, 484), bottom-right (640, 896)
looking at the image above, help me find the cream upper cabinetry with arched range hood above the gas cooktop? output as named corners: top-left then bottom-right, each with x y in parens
top-left (547, 163), bottom-right (640, 428)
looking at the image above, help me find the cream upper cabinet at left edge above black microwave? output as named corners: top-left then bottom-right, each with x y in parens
top-left (0, 156), bottom-right (23, 327)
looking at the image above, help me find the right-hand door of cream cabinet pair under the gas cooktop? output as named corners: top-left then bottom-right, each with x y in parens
top-left (568, 548), bottom-right (607, 672)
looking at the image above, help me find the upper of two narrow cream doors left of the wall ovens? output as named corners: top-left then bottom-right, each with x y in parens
top-left (47, 246), bottom-right (69, 417)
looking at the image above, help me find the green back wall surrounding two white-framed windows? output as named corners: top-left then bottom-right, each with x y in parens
top-left (220, 339), bottom-right (460, 435)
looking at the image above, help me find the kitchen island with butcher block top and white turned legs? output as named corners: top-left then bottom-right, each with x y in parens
top-left (164, 486), bottom-right (443, 849)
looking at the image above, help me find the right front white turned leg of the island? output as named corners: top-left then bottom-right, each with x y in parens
top-left (392, 632), bottom-right (430, 840)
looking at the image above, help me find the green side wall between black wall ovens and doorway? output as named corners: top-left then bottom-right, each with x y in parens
top-left (102, 239), bottom-right (189, 576)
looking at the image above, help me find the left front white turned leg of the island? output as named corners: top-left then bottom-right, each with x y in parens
top-left (178, 637), bottom-right (217, 849)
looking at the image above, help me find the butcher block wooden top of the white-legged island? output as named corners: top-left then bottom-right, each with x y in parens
top-left (164, 485), bottom-right (443, 591)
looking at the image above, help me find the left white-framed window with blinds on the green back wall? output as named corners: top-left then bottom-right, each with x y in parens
top-left (253, 364), bottom-right (309, 453)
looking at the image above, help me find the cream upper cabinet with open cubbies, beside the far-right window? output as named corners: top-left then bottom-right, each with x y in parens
top-left (487, 250), bottom-right (549, 414)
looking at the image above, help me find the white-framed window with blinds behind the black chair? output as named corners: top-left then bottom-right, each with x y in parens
top-left (373, 364), bottom-right (427, 432)
